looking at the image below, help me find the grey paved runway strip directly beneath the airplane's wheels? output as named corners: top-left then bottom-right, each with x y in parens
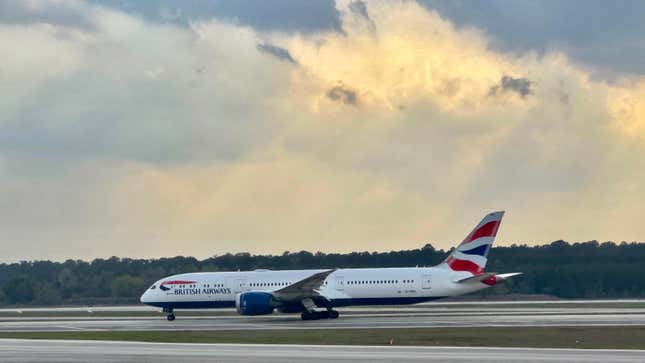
top-left (0, 304), bottom-right (645, 332)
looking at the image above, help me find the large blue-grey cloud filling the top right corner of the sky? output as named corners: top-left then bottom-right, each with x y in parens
top-left (418, 0), bottom-right (645, 80)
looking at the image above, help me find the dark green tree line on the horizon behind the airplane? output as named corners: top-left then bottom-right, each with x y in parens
top-left (0, 240), bottom-right (645, 306)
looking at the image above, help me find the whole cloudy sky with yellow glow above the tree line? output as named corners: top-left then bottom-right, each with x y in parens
top-left (0, 0), bottom-right (645, 262)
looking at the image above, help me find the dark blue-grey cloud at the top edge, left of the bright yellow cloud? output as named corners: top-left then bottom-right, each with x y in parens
top-left (90, 0), bottom-right (340, 33)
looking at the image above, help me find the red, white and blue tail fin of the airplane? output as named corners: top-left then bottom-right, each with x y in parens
top-left (439, 211), bottom-right (504, 275)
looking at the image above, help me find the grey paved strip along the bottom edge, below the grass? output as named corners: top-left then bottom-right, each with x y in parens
top-left (0, 339), bottom-right (645, 363)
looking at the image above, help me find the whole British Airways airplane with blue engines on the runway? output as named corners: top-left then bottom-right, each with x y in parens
top-left (141, 212), bottom-right (520, 321)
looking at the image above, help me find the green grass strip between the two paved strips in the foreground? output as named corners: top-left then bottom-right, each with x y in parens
top-left (0, 326), bottom-right (645, 349)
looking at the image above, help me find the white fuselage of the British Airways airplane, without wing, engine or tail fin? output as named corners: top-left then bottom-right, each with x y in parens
top-left (141, 267), bottom-right (488, 309)
